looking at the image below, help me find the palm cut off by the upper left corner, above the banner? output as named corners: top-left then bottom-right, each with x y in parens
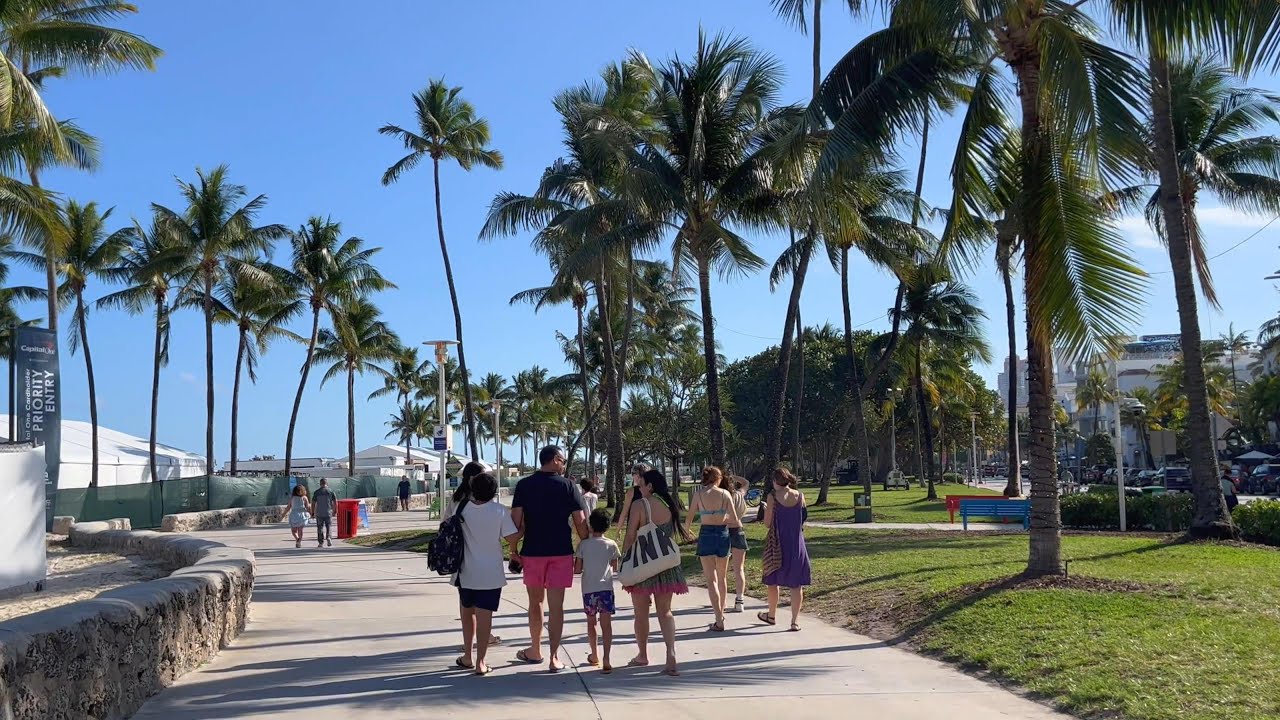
top-left (0, 0), bottom-right (161, 331)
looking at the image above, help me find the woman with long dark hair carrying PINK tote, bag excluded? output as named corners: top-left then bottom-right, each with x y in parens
top-left (622, 470), bottom-right (689, 678)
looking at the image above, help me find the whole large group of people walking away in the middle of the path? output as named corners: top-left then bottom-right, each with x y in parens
top-left (442, 446), bottom-right (810, 676)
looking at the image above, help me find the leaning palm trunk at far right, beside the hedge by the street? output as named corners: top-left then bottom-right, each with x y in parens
top-left (1151, 54), bottom-right (1238, 538)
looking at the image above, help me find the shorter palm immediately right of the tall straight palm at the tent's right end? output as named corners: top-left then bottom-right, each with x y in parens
top-left (214, 260), bottom-right (305, 475)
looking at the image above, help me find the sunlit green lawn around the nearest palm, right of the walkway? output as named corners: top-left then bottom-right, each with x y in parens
top-left (686, 527), bottom-right (1280, 720)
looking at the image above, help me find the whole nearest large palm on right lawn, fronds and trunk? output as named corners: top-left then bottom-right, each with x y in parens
top-left (855, 0), bottom-right (1157, 575)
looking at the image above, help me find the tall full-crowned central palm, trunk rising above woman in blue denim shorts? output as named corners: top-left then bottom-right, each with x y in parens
top-left (627, 31), bottom-right (782, 466)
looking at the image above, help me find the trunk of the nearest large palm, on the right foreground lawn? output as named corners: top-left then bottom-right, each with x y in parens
top-left (1006, 49), bottom-right (1064, 577)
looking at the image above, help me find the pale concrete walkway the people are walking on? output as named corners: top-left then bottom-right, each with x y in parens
top-left (134, 512), bottom-right (1065, 720)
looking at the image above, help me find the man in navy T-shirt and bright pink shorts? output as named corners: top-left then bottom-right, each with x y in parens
top-left (511, 445), bottom-right (590, 673)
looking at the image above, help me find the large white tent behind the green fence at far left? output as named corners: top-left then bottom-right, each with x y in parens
top-left (0, 415), bottom-right (205, 488)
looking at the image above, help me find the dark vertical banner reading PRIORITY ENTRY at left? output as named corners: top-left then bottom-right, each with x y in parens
top-left (13, 327), bottom-right (63, 530)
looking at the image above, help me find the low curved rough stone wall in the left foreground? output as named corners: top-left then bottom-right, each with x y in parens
top-left (0, 523), bottom-right (253, 720)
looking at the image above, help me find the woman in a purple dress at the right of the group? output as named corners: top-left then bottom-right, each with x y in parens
top-left (756, 468), bottom-right (812, 633)
